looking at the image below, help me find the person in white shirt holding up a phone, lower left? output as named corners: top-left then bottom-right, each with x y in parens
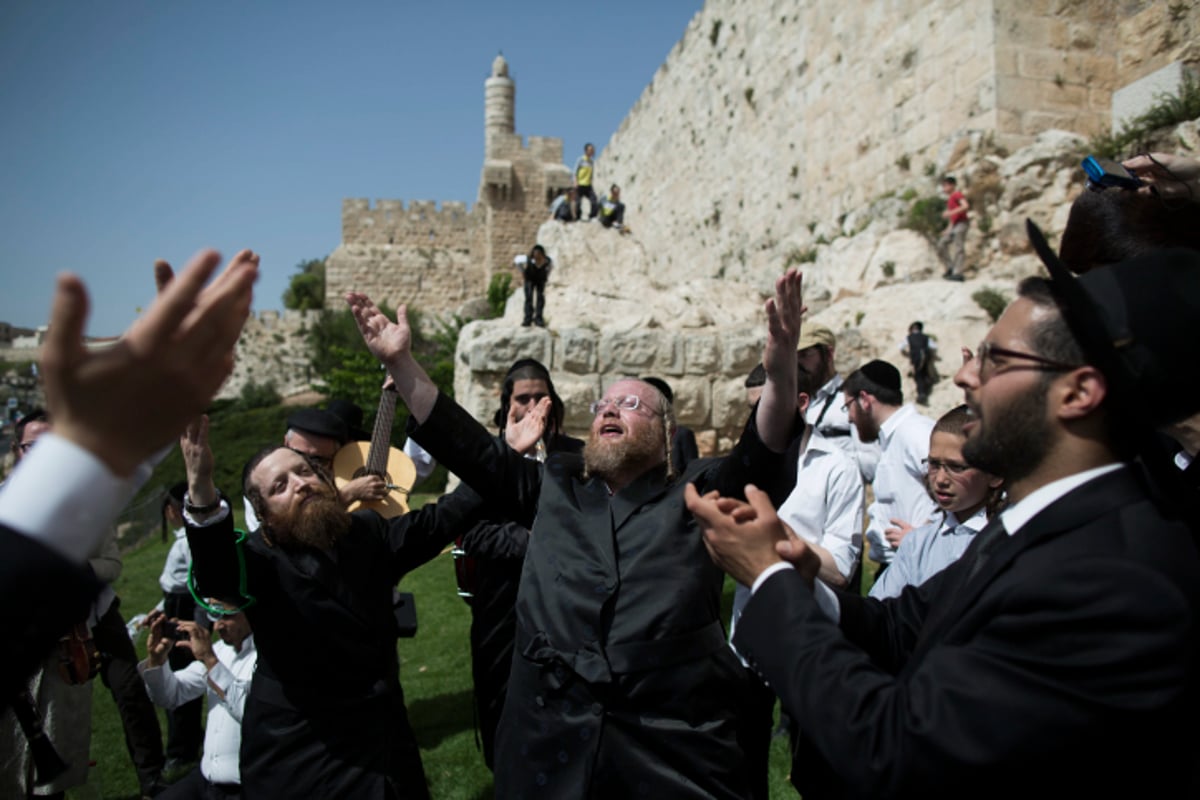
top-left (138, 597), bottom-right (258, 800)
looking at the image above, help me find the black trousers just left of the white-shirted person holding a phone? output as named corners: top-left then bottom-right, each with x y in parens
top-left (91, 597), bottom-right (164, 794)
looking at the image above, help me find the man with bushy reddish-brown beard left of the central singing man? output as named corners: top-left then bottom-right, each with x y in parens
top-left (180, 417), bottom-right (481, 799)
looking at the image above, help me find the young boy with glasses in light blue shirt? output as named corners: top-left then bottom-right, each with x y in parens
top-left (869, 405), bottom-right (1002, 600)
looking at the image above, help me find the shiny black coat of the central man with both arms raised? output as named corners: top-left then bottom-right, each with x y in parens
top-left (412, 396), bottom-right (791, 799)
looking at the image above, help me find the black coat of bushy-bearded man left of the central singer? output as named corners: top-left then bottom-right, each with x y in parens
top-left (187, 488), bottom-right (481, 800)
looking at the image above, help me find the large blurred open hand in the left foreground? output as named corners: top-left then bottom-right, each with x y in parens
top-left (42, 251), bottom-right (258, 476)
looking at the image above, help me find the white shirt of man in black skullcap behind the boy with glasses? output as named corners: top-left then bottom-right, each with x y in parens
top-left (866, 403), bottom-right (937, 564)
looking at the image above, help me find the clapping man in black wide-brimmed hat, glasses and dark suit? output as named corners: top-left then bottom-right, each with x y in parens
top-left (688, 224), bottom-right (1200, 800)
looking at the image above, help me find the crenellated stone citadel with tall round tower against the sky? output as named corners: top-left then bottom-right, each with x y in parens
top-left (325, 55), bottom-right (571, 314)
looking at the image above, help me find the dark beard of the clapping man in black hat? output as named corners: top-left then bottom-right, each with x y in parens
top-left (962, 384), bottom-right (1054, 483)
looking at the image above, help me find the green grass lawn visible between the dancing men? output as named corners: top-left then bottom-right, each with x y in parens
top-left (91, 500), bottom-right (797, 800)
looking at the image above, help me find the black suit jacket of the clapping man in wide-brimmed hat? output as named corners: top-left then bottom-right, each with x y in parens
top-left (734, 468), bottom-right (1200, 800)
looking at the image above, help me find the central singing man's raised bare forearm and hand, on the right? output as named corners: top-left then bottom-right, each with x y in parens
top-left (755, 270), bottom-right (805, 452)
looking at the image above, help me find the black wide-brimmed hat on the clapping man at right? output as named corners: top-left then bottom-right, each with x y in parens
top-left (1026, 219), bottom-right (1200, 428)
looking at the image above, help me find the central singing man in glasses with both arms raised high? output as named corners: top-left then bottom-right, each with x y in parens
top-left (347, 271), bottom-right (803, 798)
